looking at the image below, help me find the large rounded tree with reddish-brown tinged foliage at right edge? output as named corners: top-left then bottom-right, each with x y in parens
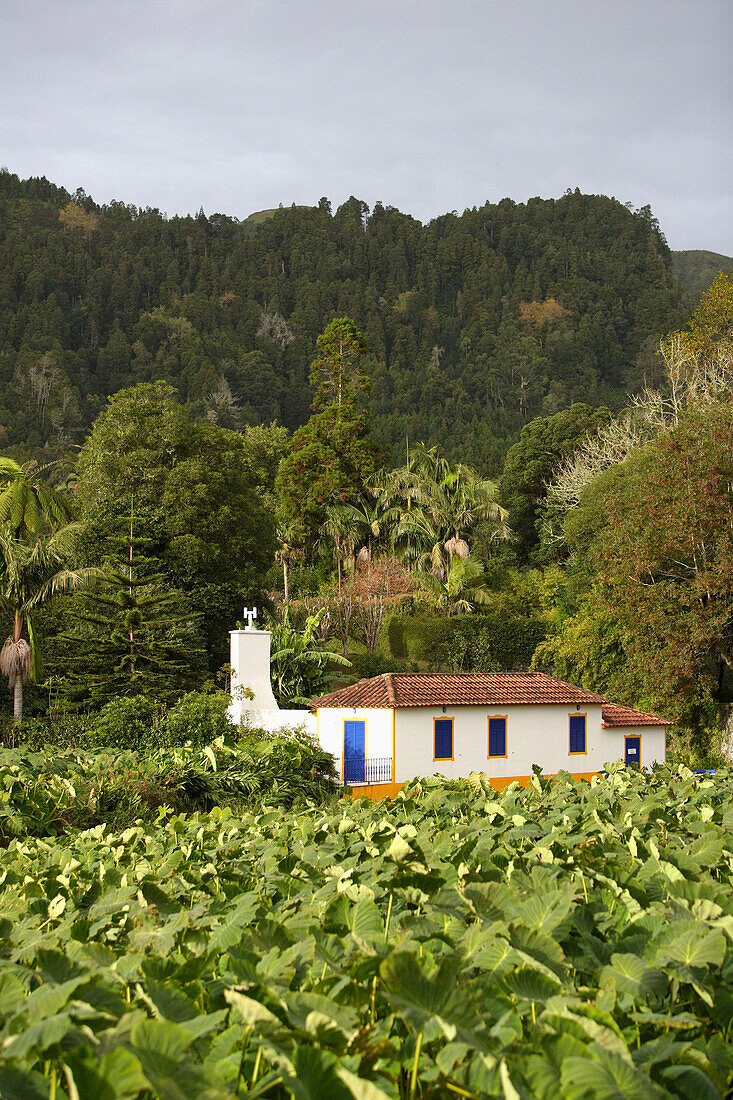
top-left (538, 404), bottom-right (733, 735)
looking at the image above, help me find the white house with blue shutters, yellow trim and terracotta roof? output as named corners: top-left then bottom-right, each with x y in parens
top-left (310, 672), bottom-right (668, 799)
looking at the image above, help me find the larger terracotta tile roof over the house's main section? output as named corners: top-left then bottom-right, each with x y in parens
top-left (310, 672), bottom-right (603, 711)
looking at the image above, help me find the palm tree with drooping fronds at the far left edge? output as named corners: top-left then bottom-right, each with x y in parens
top-left (0, 524), bottom-right (97, 722)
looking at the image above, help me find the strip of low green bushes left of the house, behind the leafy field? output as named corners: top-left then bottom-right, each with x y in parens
top-left (0, 730), bottom-right (335, 831)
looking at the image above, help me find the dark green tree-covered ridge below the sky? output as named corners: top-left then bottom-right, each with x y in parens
top-left (0, 172), bottom-right (682, 473)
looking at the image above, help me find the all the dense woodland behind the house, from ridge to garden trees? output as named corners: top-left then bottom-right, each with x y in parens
top-left (0, 173), bottom-right (733, 765)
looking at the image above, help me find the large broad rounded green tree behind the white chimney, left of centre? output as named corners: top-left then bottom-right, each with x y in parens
top-left (72, 383), bottom-right (272, 671)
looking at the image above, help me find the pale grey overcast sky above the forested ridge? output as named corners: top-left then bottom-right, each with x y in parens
top-left (0, 0), bottom-right (733, 255)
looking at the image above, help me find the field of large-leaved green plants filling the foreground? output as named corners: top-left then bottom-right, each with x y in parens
top-left (0, 765), bottom-right (733, 1100)
